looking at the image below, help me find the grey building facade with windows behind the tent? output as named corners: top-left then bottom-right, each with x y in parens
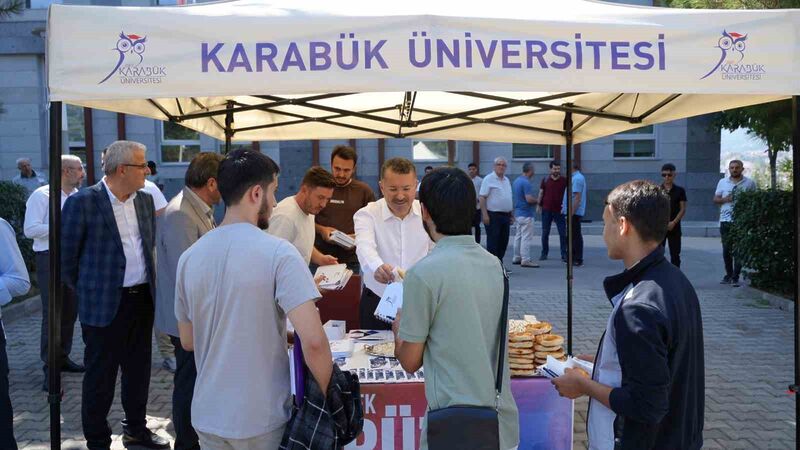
top-left (0, 0), bottom-right (720, 221)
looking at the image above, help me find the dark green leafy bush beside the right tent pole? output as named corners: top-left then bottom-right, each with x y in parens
top-left (729, 190), bottom-right (796, 298)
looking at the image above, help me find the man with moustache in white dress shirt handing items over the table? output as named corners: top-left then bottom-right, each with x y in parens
top-left (353, 158), bottom-right (433, 330)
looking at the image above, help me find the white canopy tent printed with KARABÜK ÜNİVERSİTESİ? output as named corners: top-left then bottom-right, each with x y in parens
top-left (47, 0), bottom-right (800, 448)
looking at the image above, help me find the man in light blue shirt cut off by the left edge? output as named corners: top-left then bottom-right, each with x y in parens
top-left (0, 218), bottom-right (31, 450)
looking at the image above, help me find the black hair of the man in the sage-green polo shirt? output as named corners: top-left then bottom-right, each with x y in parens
top-left (419, 167), bottom-right (476, 236)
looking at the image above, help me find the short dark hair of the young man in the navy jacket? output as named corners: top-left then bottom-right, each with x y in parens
top-left (606, 180), bottom-right (669, 242)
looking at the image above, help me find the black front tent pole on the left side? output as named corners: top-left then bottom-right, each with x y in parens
top-left (47, 102), bottom-right (63, 450)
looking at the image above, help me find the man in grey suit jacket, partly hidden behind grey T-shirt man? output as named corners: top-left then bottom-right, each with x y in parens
top-left (155, 152), bottom-right (222, 450)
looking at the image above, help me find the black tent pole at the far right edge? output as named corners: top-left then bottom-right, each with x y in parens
top-left (789, 95), bottom-right (800, 442)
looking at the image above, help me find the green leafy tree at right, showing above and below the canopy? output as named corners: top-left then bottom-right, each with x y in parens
top-left (658, 0), bottom-right (800, 189)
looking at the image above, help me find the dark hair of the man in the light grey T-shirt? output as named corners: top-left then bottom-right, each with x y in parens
top-left (217, 149), bottom-right (280, 206)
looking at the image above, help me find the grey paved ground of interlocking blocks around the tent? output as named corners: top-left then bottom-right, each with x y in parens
top-left (6, 237), bottom-right (796, 449)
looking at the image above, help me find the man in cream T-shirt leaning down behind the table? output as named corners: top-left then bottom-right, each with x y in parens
top-left (267, 166), bottom-right (337, 266)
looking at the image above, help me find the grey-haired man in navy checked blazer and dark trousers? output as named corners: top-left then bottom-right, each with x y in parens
top-left (61, 141), bottom-right (169, 450)
